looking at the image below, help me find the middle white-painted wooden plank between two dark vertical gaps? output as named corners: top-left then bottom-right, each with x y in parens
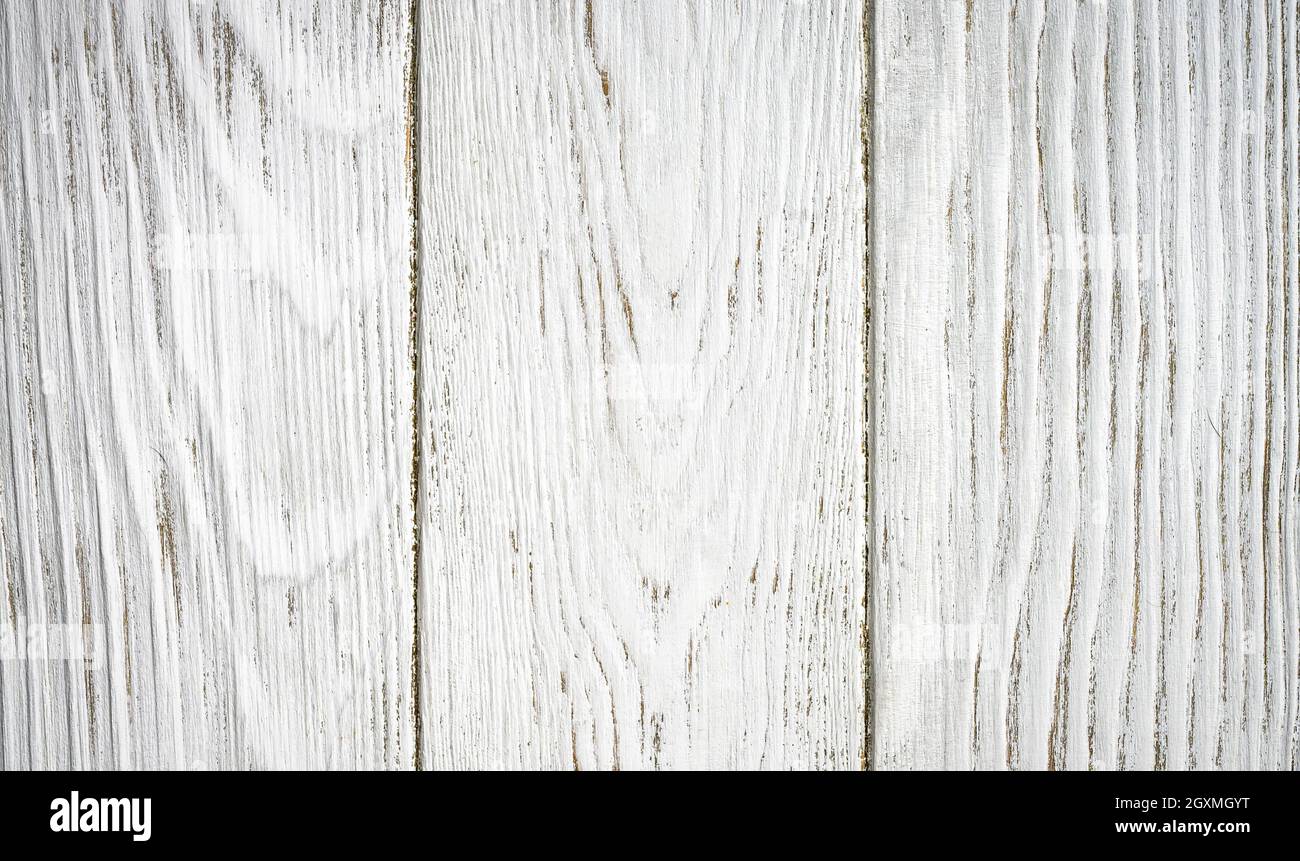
top-left (416, 0), bottom-right (866, 769)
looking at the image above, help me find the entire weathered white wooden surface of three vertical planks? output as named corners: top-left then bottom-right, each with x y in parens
top-left (0, 0), bottom-right (1300, 769)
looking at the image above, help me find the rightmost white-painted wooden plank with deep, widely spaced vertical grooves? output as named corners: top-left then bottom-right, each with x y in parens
top-left (871, 0), bottom-right (1300, 769)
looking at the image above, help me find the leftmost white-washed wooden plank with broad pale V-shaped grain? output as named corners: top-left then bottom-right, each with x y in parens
top-left (0, 1), bottom-right (413, 769)
